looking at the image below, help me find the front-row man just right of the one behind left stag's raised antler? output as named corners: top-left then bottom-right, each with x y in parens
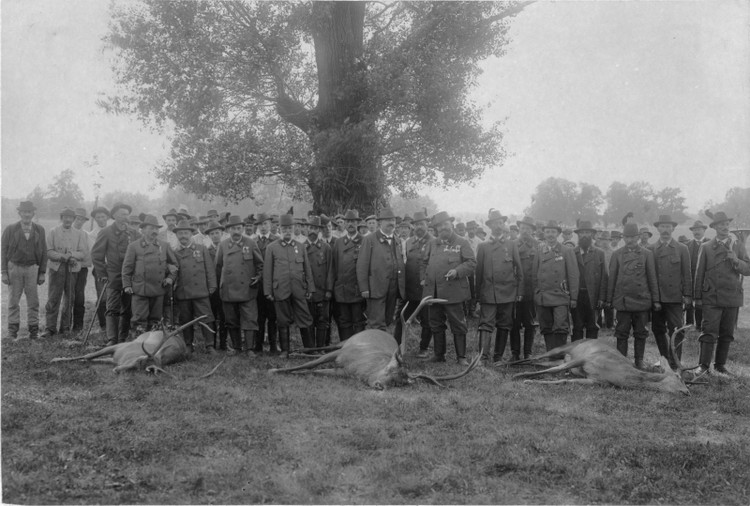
top-left (216, 216), bottom-right (263, 354)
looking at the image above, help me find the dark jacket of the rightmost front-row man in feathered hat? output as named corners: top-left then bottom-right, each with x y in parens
top-left (693, 238), bottom-right (750, 307)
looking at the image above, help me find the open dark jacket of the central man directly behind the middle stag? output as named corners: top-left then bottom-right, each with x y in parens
top-left (357, 230), bottom-right (406, 299)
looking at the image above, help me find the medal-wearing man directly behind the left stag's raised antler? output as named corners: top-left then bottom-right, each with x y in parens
top-left (174, 220), bottom-right (217, 353)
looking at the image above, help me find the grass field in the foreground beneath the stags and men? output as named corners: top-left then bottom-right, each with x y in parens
top-left (1, 228), bottom-right (750, 504)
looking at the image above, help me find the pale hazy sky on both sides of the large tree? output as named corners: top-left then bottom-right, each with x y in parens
top-left (0, 0), bottom-right (750, 214)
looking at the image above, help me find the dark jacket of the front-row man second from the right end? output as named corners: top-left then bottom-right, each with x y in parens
top-left (648, 239), bottom-right (693, 304)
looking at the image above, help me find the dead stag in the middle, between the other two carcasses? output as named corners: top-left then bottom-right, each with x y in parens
top-left (270, 297), bottom-right (481, 390)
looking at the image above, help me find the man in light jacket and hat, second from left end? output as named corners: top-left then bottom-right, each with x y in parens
top-left (41, 207), bottom-right (89, 337)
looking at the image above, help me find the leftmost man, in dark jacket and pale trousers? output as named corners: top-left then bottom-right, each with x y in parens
top-left (2, 201), bottom-right (47, 339)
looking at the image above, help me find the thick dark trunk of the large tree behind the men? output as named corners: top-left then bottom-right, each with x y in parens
top-left (308, 2), bottom-right (385, 214)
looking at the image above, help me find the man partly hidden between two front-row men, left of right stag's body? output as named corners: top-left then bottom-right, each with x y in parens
top-left (510, 216), bottom-right (539, 358)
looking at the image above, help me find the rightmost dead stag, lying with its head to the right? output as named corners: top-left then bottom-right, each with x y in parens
top-left (511, 327), bottom-right (697, 395)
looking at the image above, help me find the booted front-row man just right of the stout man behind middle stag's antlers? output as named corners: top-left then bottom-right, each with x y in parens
top-left (476, 210), bottom-right (523, 364)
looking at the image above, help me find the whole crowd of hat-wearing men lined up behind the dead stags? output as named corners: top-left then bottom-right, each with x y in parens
top-left (2, 202), bottom-right (750, 373)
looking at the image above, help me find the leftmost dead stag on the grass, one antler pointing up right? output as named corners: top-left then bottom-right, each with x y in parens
top-left (52, 315), bottom-right (206, 373)
